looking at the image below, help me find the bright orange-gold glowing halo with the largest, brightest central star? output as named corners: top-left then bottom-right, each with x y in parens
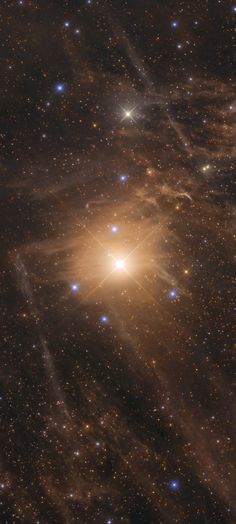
top-left (70, 215), bottom-right (160, 304)
